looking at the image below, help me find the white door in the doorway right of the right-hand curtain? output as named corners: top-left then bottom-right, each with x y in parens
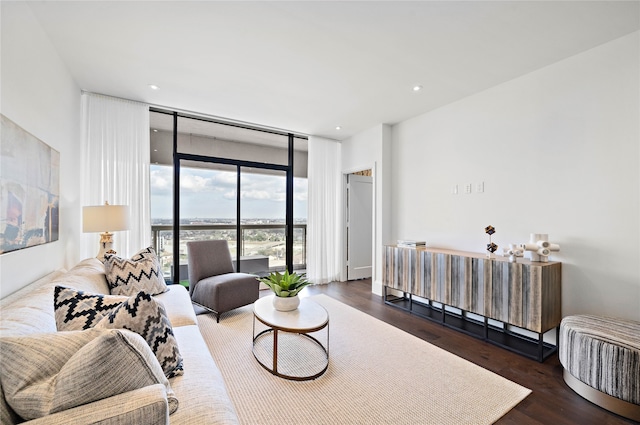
top-left (347, 174), bottom-right (373, 280)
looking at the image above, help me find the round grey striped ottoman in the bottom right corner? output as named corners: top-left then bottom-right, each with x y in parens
top-left (558, 315), bottom-right (640, 421)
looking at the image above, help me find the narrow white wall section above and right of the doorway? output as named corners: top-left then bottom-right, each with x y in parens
top-left (342, 124), bottom-right (393, 295)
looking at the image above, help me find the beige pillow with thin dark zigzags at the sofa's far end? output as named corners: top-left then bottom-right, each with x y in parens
top-left (104, 247), bottom-right (167, 296)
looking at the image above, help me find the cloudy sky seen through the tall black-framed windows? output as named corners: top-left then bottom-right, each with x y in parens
top-left (150, 164), bottom-right (307, 220)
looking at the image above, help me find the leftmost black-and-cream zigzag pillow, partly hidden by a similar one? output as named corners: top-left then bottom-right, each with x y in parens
top-left (53, 286), bottom-right (129, 331)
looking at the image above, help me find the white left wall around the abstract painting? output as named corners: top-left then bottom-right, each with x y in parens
top-left (0, 2), bottom-right (81, 297)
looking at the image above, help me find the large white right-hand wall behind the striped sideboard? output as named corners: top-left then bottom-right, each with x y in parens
top-left (388, 32), bottom-right (640, 320)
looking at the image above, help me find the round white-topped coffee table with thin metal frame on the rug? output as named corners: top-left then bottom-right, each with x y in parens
top-left (253, 296), bottom-right (329, 381)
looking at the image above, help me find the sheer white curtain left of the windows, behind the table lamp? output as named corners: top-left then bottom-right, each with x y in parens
top-left (80, 93), bottom-right (151, 258)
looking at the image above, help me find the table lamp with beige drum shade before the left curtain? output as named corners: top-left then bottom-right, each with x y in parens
top-left (82, 201), bottom-right (129, 261)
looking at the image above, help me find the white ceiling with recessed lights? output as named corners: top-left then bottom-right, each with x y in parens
top-left (29, 1), bottom-right (640, 139)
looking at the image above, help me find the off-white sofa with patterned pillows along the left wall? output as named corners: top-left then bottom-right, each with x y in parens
top-left (0, 258), bottom-right (238, 425)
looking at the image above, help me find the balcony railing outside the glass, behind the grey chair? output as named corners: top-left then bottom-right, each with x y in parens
top-left (151, 224), bottom-right (307, 281)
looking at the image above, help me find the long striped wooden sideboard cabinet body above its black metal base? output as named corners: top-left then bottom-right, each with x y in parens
top-left (382, 245), bottom-right (562, 334)
